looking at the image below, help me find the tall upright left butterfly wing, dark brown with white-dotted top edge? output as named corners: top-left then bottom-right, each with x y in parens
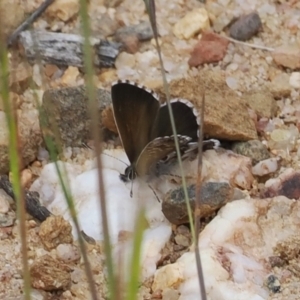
top-left (111, 81), bottom-right (160, 164)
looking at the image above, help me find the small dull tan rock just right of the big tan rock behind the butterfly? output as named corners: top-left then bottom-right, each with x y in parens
top-left (243, 89), bottom-right (278, 118)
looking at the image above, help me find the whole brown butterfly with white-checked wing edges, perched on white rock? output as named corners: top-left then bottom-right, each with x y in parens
top-left (111, 80), bottom-right (215, 182)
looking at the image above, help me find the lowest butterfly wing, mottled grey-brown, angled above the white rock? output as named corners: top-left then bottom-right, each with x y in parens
top-left (135, 135), bottom-right (191, 176)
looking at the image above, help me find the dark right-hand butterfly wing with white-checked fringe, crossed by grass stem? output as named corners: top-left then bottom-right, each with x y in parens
top-left (152, 98), bottom-right (200, 141)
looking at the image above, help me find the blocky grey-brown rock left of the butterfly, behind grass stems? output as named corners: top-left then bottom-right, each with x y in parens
top-left (40, 86), bottom-right (111, 147)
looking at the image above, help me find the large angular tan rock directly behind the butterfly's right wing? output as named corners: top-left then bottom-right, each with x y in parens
top-left (158, 71), bottom-right (257, 141)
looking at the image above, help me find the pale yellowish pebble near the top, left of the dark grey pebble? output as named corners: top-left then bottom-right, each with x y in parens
top-left (173, 8), bottom-right (210, 40)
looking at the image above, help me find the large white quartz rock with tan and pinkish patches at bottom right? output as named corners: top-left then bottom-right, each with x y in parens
top-left (153, 196), bottom-right (300, 300)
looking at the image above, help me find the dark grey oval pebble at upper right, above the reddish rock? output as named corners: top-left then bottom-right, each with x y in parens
top-left (229, 12), bottom-right (262, 41)
